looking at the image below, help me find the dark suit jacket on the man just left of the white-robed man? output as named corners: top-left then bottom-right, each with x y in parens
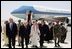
top-left (19, 25), bottom-right (31, 36)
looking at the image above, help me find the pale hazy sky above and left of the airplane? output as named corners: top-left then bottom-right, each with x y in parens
top-left (1, 1), bottom-right (71, 20)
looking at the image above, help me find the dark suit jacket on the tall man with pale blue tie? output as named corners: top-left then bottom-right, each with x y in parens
top-left (6, 23), bottom-right (17, 37)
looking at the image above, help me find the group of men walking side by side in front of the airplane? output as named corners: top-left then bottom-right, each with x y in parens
top-left (1, 18), bottom-right (67, 48)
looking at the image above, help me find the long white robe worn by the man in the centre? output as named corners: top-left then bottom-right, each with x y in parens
top-left (30, 25), bottom-right (40, 46)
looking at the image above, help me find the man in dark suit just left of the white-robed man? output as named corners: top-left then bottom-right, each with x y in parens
top-left (19, 23), bottom-right (31, 48)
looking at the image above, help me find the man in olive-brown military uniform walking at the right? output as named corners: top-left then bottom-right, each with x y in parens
top-left (53, 21), bottom-right (61, 47)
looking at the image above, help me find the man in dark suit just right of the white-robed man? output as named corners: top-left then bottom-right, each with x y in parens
top-left (39, 20), bottom-right (46, 48)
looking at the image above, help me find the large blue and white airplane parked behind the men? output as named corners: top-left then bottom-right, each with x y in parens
top-left (11, 6), bottom-right (71, 24)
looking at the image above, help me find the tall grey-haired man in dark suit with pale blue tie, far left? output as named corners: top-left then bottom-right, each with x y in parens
top-left (6, 18), bottom-right (17, 48)
